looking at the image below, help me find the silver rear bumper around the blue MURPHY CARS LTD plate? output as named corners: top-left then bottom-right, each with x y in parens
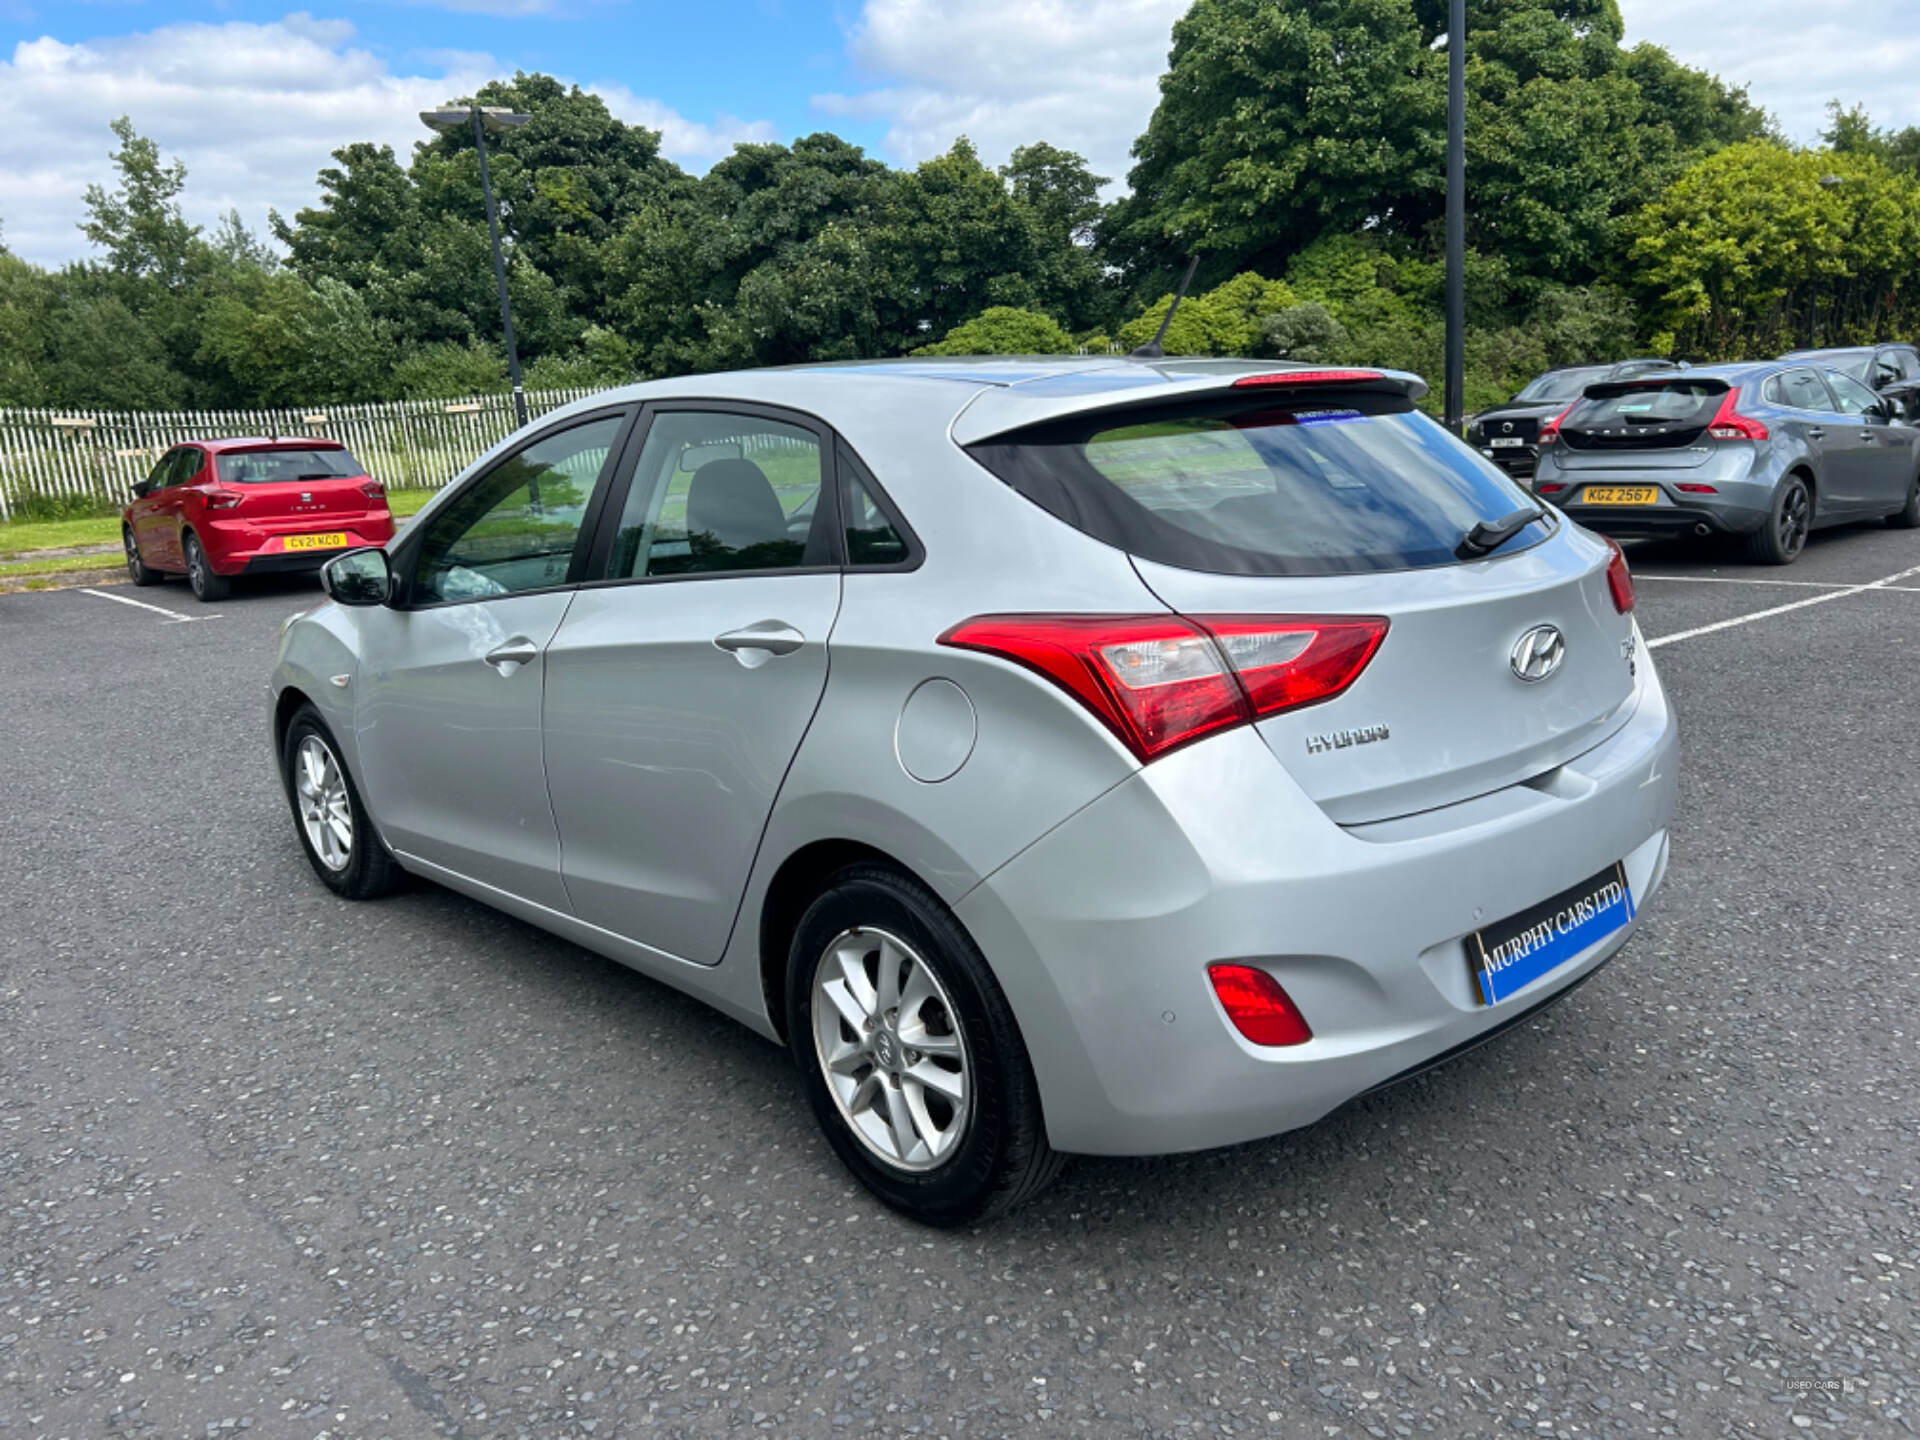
top-left (956, 651), bottom-right (1678, 1154)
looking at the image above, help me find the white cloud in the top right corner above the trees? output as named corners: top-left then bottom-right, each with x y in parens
top-left (1620, 0), bottom-right (1920, 144)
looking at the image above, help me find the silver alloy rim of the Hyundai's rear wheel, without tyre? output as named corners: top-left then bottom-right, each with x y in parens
top-left (812, 927), bottom-right (973, 1171)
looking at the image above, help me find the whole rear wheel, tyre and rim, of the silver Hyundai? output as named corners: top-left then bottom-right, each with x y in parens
top-left (787, 864), bottom-right (1066, 1227)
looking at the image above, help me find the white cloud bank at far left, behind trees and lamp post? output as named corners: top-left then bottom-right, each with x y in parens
top-left (0, 13), bottom-right (770, 265)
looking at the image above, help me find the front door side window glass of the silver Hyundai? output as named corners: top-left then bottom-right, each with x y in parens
top-left (413, 415), bottom-right (620, 605)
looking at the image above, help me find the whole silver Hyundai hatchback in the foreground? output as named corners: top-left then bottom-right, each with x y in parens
top-left (273, 359), bottom-right (1676, 1225)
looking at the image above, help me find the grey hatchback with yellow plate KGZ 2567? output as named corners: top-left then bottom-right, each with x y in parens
top-left (1534, 361), bottom-right (1920, 564)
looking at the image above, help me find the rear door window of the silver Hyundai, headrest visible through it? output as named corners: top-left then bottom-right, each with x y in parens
top-left (607, 411), bottom-right (831, 580)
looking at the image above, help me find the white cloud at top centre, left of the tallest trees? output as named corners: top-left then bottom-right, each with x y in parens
top-left (814, 0), bottom-right (1188, 190)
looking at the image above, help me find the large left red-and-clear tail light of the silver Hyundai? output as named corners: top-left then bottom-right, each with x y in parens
top-left (941, 614), bottom-right (1386, 764)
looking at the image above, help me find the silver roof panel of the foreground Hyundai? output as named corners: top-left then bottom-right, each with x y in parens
top-left (557, 355), bottom-right (1427, 445)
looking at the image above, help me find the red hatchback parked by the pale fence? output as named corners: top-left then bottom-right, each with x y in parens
top-left (121, 440), bottom-right (394, 601)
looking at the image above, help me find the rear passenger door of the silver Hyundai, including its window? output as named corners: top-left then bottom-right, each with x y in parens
top-left (545, 403), bottom-right (841, 964)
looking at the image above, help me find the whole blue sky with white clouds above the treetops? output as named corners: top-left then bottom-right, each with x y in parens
top-left (0, 0), bottom-right (1920, 263)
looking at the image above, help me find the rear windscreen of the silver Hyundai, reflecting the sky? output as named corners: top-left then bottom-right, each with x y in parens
top-left (968, 390), bottom-right (1549, 576)
